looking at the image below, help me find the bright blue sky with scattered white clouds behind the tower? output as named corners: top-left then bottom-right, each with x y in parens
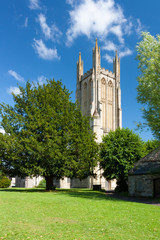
top-left (0, 0), bottom-right (160, 140)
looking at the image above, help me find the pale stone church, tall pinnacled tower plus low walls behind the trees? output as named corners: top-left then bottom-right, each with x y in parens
top-left (11, 39), bottom-right (122, 190)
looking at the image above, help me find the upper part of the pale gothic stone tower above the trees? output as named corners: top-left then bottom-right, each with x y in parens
top-left (76, 39), bottom-right (122, 143)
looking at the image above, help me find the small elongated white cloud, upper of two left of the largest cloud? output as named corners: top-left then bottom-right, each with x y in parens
top-left (38, 13), bottom-right (62, 41)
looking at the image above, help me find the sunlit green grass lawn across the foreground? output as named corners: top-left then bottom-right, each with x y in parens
top-left (0, 189), bottom-right (160, 240)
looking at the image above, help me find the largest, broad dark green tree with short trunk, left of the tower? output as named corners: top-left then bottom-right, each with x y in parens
top-left (1, 80), bottom-right (98, 189)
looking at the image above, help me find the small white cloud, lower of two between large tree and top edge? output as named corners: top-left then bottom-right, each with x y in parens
top-left (33, 39), bottom-right (60, 60)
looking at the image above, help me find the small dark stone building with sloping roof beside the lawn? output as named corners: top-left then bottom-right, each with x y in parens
top-left (128, 147), bottom-right (160, 197)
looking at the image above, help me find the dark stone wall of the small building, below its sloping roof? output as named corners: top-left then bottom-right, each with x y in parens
top-left (128, 174), bottom-right (160, 197)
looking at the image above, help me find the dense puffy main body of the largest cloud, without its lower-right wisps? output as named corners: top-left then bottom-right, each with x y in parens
top-left (67, 0), bottom-right (129, 44)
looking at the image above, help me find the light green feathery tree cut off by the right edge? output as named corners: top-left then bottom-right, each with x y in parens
top-left (137, 32), bottom-right (160, 140)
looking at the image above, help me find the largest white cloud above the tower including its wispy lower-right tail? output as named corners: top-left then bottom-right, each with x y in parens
top-left (66, 0), bottom-right (138, 63)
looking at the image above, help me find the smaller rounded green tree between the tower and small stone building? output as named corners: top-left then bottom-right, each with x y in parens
top-left (100, 128), bottom-right (143, 191)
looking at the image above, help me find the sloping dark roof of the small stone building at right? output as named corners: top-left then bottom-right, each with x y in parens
top-left (129, 147), bottom-right (160, 175)
